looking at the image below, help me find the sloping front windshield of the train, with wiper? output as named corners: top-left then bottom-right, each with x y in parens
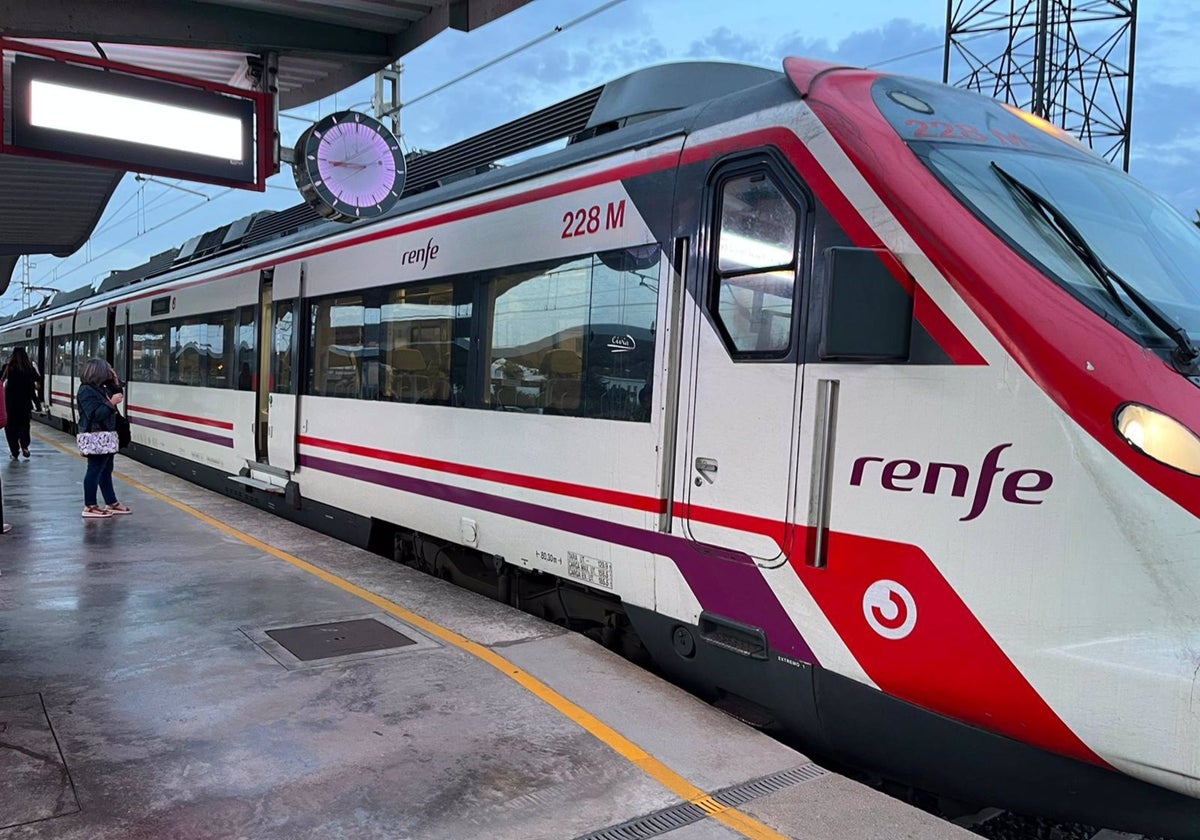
top-left (876, 79), bottom-right (1200, 348)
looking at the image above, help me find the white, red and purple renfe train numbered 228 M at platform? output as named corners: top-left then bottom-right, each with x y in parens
top-left (7, 58), bottom-right (1200, 838)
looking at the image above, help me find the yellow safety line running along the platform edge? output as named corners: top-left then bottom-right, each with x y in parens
top-left (35, 434), bottom-right (787, 840)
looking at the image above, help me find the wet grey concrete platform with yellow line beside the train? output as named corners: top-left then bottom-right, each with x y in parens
top-left (0, 427), bottom-right (974, 840)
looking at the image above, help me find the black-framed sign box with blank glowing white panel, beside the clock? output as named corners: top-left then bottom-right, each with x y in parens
top-left (11, 55), bottom-right (258, 187)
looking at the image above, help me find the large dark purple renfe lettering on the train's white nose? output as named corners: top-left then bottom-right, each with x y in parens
top-left (850, 443), bottom-right (1054, 522)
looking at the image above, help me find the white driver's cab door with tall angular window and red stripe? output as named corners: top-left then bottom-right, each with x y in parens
top-left (678, 155), bottom-right (808, 564)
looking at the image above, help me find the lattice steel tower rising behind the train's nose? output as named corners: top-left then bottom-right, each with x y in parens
top-left (942, 0), bottom-right (1138, 170)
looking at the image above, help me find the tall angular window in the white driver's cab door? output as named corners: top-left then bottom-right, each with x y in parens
top-left (714, 172), bottom-right (798, 356)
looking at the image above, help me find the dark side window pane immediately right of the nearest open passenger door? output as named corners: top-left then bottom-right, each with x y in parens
top-left (308, 282), bottom-right (472, 406)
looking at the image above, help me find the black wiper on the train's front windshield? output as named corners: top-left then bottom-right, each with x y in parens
top-left (991, 161), bottom-right (1200, 376)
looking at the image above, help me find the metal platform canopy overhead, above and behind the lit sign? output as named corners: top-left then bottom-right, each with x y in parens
top-left (0, 0), bottom-right (529, 294)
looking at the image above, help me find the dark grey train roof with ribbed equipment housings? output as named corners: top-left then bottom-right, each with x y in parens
top-left (0, 61), bottom-right (794, 330)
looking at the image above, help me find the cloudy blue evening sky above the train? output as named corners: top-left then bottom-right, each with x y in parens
top-left (0, 0), bottom-right (1200, 317)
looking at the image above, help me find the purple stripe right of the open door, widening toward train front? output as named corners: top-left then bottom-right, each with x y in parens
top-left (300, 455), bottom-right (817, 664)
